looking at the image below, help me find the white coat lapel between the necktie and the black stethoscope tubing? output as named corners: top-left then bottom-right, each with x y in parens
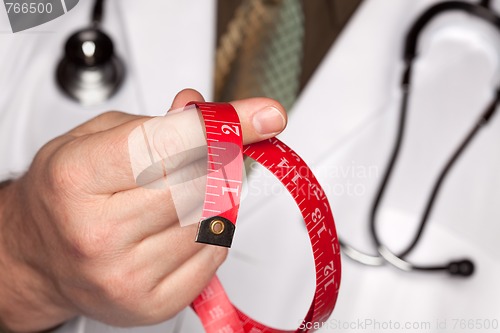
top-left (281, 0), bottom-right (442, 166)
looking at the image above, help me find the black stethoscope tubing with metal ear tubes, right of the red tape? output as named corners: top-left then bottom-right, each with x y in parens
top-left (340, 0), bottom-right (500, 277)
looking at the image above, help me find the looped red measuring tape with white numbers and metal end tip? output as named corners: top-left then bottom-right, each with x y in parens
top-left (190, 103), bottom-right (340, 333)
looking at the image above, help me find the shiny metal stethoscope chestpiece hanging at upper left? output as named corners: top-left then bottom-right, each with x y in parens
top-left (56, 27), bottom-right (125, 106)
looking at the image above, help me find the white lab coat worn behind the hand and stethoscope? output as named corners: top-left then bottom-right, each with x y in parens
top-left (0, 0), bottom-right (500, 333)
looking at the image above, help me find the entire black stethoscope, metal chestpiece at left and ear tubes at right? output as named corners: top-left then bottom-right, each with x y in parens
top-left (57, 0), bottom-right (500, 277)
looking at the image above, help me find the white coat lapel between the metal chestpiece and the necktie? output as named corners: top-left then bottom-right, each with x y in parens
top-left (120, 0), bottom-right (216, 115)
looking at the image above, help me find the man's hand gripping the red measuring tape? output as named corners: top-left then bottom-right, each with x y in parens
top-left (0, 90), bottom-right (286, 332)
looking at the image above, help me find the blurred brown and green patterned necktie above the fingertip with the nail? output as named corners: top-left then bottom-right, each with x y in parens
top-left (214, 0), bottom-right (304, 109)
